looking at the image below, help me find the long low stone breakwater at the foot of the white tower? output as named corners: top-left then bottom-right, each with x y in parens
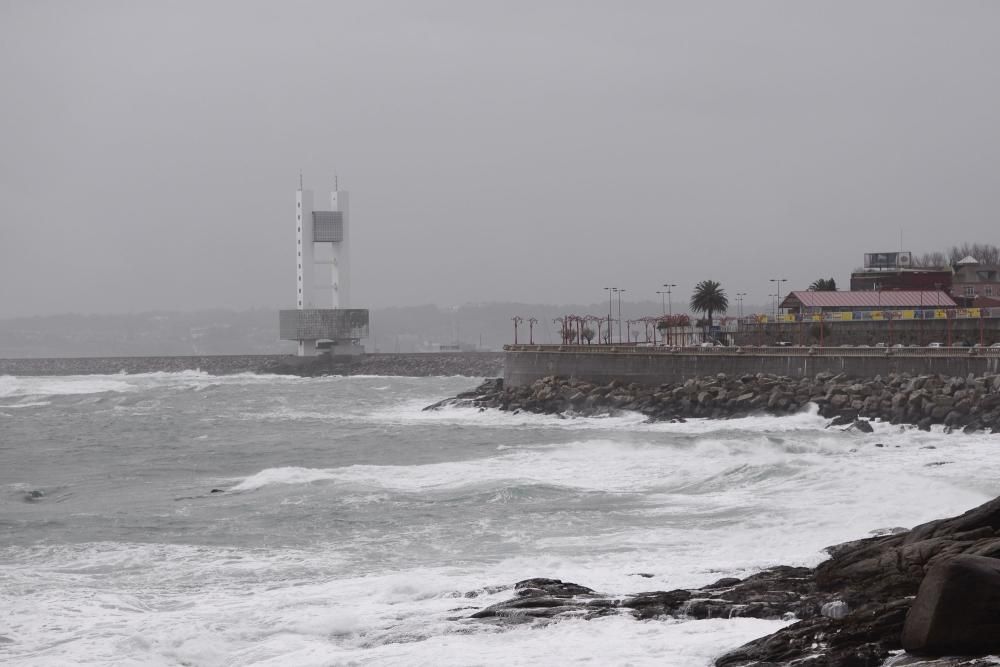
top-left (0, 352), bottom-right (503, 377)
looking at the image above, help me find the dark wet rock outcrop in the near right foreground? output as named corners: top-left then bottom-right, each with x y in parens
top-left (469, 498), bottom-right (1000, 667)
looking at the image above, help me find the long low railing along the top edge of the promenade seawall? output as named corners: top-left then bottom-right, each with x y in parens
top-left (503, 343), bottom-right (1000, 357)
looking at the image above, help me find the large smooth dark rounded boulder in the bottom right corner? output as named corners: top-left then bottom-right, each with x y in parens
top-left (902, 555), bottom-right (1000, 655)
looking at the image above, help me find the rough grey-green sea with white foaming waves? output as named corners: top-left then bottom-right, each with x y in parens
top-left (0, 372), bottom-right (1000, 667)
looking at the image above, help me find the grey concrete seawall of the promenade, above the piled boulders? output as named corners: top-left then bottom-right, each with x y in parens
top-left (504, 345), bottom-right (1000, 387)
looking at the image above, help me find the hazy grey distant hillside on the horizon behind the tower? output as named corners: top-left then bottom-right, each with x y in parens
top-left (0, 301), bottom-right (772, 358)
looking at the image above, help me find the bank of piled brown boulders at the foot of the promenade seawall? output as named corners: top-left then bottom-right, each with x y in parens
top-left (426, 373), bottom-right (1000, 433)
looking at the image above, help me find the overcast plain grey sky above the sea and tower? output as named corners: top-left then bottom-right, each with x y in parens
top-left (0, 0), bottom-right (1000, 317)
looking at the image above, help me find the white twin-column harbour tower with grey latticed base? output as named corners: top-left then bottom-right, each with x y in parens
top-left (280, 176), bottom-right (368, 356)
